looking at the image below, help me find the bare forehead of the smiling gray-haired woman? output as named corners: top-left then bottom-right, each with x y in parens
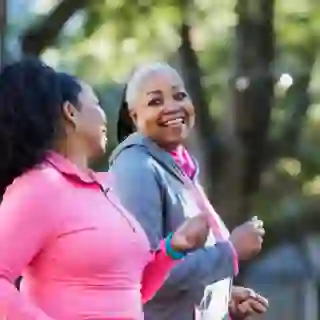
top-left (140, 70), bottom-right (184, 93)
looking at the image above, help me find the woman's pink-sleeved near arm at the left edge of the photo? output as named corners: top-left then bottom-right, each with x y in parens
top-left (0, 178), bottom-right (53, 320)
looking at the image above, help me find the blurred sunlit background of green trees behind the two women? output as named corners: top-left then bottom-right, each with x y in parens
top-left (0, 0), bottom-right (320, 320)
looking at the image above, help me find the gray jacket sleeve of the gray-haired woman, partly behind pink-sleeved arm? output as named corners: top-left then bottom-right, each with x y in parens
top-left (110, 149), bottom-right (237, 303)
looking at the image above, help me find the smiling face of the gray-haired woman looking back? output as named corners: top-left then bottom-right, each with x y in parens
top-left (129, 67), bottom-right (195, 149)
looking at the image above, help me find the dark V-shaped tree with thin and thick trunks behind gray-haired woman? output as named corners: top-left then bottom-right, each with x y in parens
top-left (172, 0), bottom-right (274, 230)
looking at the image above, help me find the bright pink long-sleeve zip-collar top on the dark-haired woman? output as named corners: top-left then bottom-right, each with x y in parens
top-left (0, 152), bottom-right (175, 320)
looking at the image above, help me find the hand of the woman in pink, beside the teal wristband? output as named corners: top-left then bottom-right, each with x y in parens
top-left (171, 215), bottom-right (209, 252)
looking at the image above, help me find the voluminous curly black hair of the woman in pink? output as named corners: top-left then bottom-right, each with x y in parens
top-left (0, 57), bottom-right (81, 197)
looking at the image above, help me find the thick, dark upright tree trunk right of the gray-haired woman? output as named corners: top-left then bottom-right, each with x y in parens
top-left (220, 0), bottom-right (274, 226)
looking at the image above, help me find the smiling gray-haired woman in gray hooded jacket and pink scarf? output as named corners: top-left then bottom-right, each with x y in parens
top-left (110, 63), bottom-right (267, 320)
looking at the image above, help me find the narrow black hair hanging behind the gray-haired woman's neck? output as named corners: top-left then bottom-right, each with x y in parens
top-left (117, 85), bottom-right (136, 143)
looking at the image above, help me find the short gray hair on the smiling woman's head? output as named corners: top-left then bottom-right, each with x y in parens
top-left (125, 62), bottom-right (181, 109)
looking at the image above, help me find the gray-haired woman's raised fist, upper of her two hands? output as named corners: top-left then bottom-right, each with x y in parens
top-left (230, 219), bottom-right (265, 260)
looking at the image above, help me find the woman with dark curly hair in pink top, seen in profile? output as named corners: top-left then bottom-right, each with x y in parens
top-left (0, 59), bottom-right (208, 320)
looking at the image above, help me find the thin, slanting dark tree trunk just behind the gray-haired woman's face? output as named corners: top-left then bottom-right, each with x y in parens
top-left (178, 1), bottom-right (224, 199)
